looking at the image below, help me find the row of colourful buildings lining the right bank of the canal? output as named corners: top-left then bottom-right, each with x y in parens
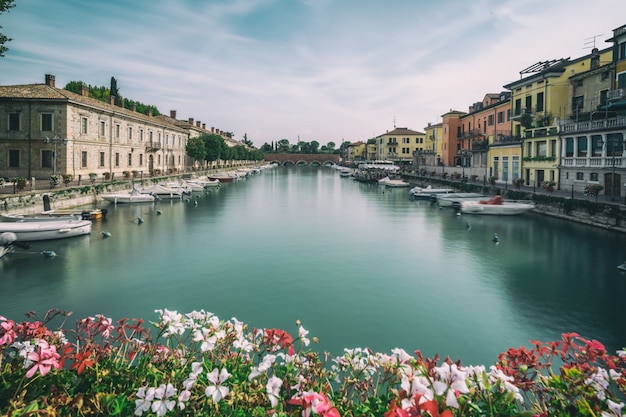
top-left (346, 25), bottom-right (626, 197)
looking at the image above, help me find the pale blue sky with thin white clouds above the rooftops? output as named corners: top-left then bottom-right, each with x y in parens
top-left (0, 0), bottom-right (626, 147)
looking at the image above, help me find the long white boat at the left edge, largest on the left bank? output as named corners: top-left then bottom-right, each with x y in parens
top-left (0, 220), bottom-right (91, 242)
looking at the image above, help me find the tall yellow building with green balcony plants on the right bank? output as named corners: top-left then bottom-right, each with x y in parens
top-left (502, 48), bottom-right (612, 187)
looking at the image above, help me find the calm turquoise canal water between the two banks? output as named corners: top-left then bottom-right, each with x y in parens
top-left (0, 167), bottom-right (626, 365)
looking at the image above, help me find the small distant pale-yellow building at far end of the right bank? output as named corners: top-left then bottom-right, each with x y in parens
top-left (376, 127), bottom-right (426, 164)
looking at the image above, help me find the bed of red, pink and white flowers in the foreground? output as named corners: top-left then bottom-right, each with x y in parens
top-left (0, 310), bottom-right (626, 417)
